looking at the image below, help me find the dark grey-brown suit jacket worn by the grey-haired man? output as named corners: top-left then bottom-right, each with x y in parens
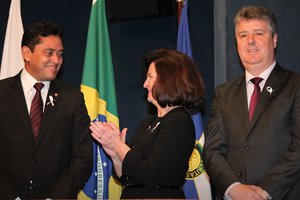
top-left (204, 64), bottom-right (300, 199)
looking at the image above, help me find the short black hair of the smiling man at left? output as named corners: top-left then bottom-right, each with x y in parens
top-left (21, 22), bottom-right (62, 51)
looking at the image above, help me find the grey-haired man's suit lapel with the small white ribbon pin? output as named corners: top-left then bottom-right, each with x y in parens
top-left (249, 64), bottom-right (289, 131)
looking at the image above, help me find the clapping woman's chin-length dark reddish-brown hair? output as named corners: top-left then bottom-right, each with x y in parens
top-left (144, 49), bottom-right (204, 109)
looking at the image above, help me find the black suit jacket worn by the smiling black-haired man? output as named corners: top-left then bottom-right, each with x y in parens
top-left (0, 73), bottom-right (92, 199)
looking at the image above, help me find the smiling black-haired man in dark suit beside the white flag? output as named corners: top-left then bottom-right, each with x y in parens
top-left (0, 22), bottom-right (92, 199)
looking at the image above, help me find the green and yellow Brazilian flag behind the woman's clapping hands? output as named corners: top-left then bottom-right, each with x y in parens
top-left (78, 0), bottom-right (121, 199)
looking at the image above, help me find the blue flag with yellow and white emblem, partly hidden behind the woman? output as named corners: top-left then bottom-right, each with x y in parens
top-left (177, 0), bottom-right (212, 200)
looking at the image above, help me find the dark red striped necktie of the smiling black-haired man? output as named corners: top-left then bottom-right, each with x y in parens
top-left (30, 83), bottom-right (44, 138)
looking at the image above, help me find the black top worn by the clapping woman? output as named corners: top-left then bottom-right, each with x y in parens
top-left (121, 107), bottom-right (195, 199)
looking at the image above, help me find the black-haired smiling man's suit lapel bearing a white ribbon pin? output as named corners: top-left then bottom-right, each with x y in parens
top-left (36, 80), bottom-right (61, 147)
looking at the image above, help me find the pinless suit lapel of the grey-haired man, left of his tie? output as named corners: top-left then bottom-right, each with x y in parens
top-left (235, 76), bottom-right (250, 131)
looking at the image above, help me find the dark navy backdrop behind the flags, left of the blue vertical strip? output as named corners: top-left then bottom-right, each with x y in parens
top-left (0, 0), bottom-right (214, 141)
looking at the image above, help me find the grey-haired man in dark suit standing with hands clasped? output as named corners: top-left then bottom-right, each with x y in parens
top-left (204, 6), bottom-right (300, 200)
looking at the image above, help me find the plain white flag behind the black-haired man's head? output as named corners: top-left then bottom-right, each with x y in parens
top-left (0, 0), bottom-right (24, 79)
